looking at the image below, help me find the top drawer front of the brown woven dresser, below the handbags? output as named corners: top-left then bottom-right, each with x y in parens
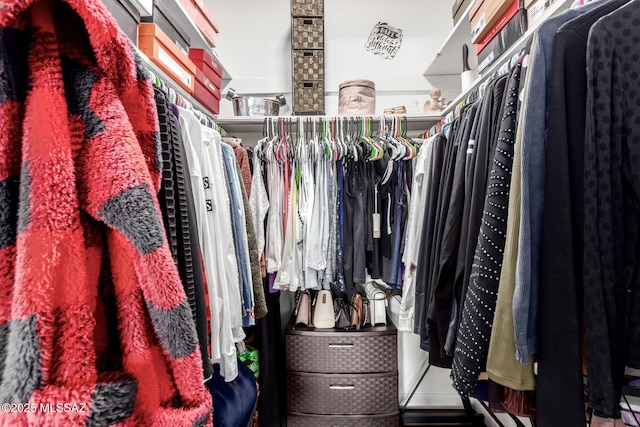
top-left (285, 334), bottom-right (398, 373)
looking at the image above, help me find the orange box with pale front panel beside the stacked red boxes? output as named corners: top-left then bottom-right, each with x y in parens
top-left (138, 23), bottom-right (196, 93)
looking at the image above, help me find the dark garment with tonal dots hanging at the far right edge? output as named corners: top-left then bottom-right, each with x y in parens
top-left (583, 1), bottom-right (640, 417)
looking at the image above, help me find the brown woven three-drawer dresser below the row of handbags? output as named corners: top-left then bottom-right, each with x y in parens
top-left (285, 324), bottom-right (400, 427)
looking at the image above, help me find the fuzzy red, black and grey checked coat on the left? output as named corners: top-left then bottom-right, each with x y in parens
top-left (0, 0), bottom-right (211, 426)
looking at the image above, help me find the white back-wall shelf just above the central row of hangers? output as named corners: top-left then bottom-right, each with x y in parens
top-left (214, 114), bottom-right (440, 136)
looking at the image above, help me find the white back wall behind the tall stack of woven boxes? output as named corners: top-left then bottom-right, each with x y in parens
top-left (205, 0), bottom-right (462, 115)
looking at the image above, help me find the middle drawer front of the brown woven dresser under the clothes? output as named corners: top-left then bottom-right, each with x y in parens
top-left (287, 372), bottom-right (398, 415)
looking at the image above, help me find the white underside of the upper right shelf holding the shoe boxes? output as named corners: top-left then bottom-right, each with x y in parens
top-left (424, 1), bottom-right (478, 77)
